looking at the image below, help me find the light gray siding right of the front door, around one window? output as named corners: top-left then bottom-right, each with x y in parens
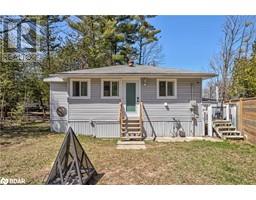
top-left (141, 78), bottom-right (204, 137)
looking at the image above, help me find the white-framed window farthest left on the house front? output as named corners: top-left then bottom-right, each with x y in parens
top-left (71, 80), bottom-right (90, 98)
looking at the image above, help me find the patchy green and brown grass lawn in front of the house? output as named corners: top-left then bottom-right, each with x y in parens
top-left (0, 123), bottom-right (256, 184)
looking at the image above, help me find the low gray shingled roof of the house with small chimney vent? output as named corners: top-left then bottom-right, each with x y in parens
top-left (45, 65), bottom-right (216, 78)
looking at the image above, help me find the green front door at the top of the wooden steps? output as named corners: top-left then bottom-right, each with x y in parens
top-left (126, 83), bottom-right (136, 112)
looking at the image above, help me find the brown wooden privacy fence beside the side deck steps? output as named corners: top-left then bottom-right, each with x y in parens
top-left (226, 97), bottom-right (256, 143)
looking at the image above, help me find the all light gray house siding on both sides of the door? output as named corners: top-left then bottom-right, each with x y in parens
top-left (51, 78), bottom-right (203, 138)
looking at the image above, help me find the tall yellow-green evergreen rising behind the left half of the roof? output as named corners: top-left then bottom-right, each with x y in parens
top-left (69, 16), bottom-right (113, 68)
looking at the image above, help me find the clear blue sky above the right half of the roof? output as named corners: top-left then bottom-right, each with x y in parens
top-left (150, 16), bottom-right (225, 71)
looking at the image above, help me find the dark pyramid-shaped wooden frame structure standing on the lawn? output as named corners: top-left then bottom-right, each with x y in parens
top-left (46, 127), bottom-right (97, 185)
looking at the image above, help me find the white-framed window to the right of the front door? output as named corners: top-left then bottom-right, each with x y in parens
top-left (157, 79), bottom-right (177, 99)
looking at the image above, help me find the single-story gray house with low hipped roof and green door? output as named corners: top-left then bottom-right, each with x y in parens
top-left (44, 62), bottom-right (216, 139)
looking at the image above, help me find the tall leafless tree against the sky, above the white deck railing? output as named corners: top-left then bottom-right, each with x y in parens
top-left (210, 16), bottom-right (255, 102)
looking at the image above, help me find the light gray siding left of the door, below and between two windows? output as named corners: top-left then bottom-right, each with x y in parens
top-left (68, 78), bottom-right (120, 138)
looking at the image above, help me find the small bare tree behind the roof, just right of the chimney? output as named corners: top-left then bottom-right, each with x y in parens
top-left (141, 41), bottom-right (164, 66)
